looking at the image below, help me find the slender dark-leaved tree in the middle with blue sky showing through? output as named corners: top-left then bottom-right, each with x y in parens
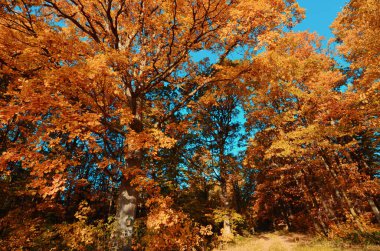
top-left (192, 78), bottom-right (242, 238)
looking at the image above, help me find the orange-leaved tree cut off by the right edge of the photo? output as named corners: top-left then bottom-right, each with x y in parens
top-left (332, 1), bottom-right (380, 226)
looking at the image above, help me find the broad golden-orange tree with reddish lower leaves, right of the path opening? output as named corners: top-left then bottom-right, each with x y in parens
top-left (247, 33), bottom-right (378, 235)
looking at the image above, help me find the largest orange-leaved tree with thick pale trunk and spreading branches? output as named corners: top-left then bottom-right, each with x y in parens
top-left (0, 0), bottom-right (302, 248)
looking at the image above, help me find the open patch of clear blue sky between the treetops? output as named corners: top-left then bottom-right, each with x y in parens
top-left (295, 0), bottom-right (348, 40)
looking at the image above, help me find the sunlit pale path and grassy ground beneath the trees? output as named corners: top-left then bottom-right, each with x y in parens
top-left (214, 233), bottom-right (380, 251)
